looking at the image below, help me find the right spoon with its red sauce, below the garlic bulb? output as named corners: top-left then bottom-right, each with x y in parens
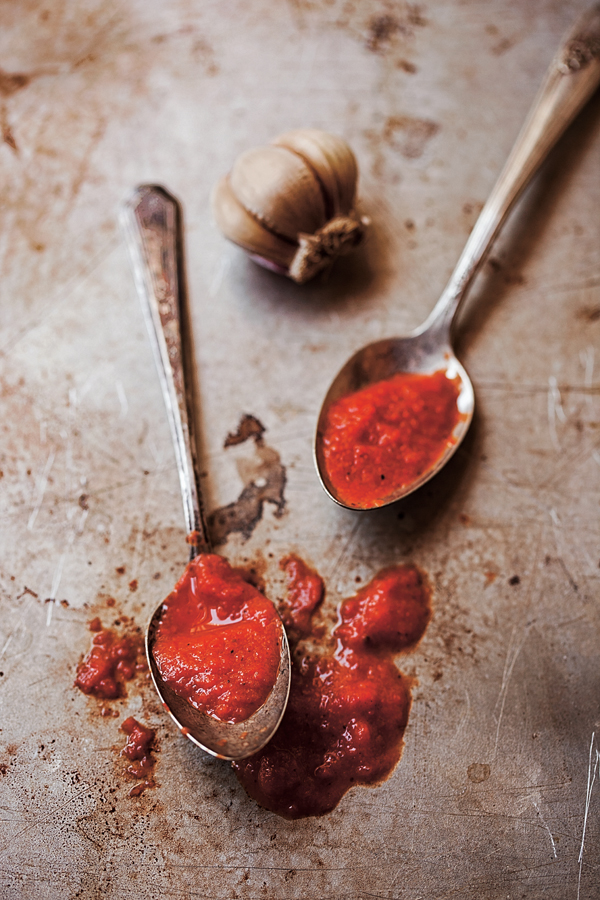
top-left (315, 4), bottom-right (600, 510)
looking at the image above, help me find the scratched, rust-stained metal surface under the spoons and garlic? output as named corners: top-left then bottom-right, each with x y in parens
top-left (0, 0), bottom-right (600, 900)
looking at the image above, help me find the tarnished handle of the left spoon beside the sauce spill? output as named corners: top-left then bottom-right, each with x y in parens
top-left (122, 185), bottom-right (210, 559)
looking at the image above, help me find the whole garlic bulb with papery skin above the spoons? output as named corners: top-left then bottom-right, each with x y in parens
top-left (212, 128), bottom-right (368, 284)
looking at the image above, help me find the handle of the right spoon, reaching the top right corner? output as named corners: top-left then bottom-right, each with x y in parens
top-left (419, 3), bottom-right (600, 339)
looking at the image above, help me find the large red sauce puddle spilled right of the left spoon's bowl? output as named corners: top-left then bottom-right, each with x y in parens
top-left (233, 557), bottom-right (431, 819)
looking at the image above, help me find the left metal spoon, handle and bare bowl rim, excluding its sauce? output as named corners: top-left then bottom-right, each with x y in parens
top-left (122, 185), bottom-right (290, 759)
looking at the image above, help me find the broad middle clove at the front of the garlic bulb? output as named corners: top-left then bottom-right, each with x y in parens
top-left (230, 146), bottom-right (326, 242)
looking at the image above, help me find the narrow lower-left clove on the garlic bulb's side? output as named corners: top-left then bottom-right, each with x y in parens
top-left (211, 176), bottom-right (297, 269)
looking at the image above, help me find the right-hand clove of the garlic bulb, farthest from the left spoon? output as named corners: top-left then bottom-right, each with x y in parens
top-left (272, 128), bottom-right (358, 218)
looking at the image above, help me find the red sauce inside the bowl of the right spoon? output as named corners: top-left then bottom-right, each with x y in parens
top-left (323, 371), bottom-right (463, 509)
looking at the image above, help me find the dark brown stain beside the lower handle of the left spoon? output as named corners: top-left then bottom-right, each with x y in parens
top-left (208, 415), bottom-right (287, 547)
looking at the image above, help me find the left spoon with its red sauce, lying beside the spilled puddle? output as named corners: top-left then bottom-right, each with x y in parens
top-left (122, 185), bottom-right (290, 760)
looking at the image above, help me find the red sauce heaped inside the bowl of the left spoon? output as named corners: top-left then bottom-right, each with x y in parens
top-left (153, 553), bottom-right (280, 722)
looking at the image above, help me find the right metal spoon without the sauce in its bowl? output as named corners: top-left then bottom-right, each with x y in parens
top-left (315, 4), bottom-right (600, 509)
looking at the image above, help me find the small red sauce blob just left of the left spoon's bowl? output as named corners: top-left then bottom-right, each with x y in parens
top-left (75, 618), bottom-right (142, 700)
